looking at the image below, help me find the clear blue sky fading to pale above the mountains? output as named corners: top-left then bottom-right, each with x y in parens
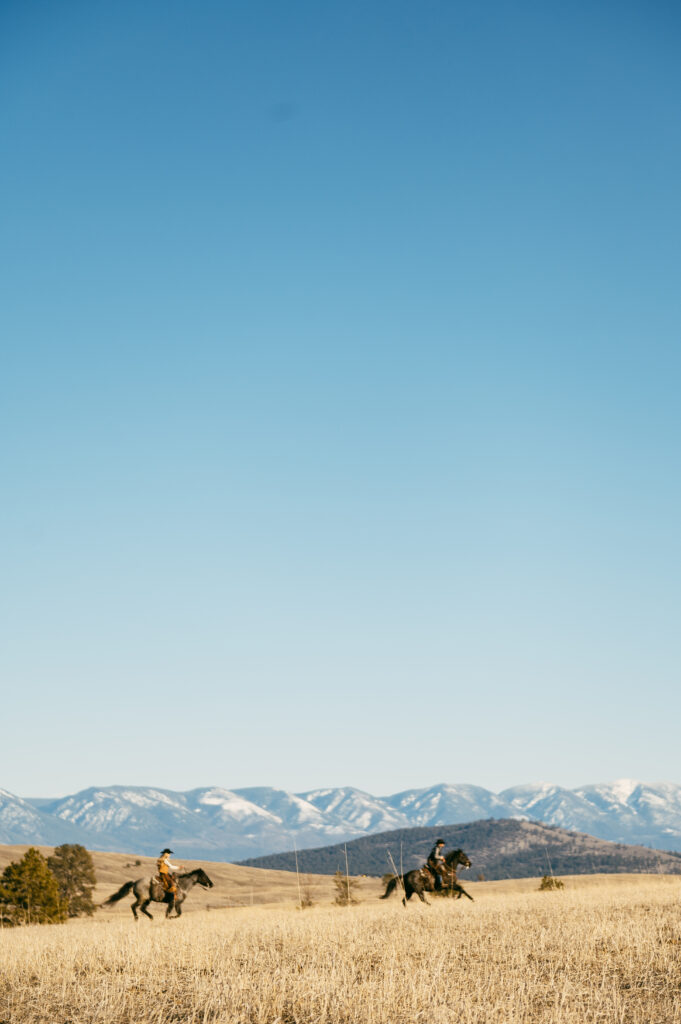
top-left (0, 0), bottom-right (681, 796)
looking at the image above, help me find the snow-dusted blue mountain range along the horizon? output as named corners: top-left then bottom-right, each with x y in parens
top-left (0, 779), bottom-right (681, 860)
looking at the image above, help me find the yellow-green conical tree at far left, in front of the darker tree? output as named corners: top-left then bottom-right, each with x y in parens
top-left (0, 846), bottom-right (67, 925)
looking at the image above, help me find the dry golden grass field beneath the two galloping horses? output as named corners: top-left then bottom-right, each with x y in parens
top-left (0, 854), bottom-right (681, 1024)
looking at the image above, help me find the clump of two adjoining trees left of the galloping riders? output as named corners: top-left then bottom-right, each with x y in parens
top-left (0, 843), bottom-right (96, 926)
